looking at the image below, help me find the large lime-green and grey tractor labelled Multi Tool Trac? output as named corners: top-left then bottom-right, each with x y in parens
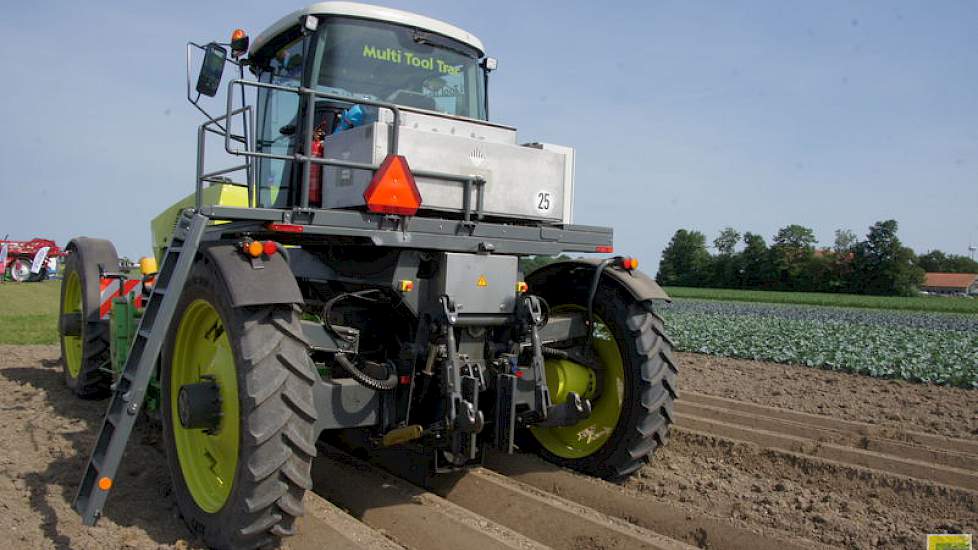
top-left (59, 2), bottom-right (677, 548)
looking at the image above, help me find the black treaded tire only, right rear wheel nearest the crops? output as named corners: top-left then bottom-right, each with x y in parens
top-left (525, 278), bottom-right (678, 481)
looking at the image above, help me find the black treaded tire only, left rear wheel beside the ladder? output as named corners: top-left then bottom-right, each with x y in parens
top-left (161, 259), bottom-right (317, 549)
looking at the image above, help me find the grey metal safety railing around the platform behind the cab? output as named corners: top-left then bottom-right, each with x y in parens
top-left (217, 79), bottom-right (486, 222)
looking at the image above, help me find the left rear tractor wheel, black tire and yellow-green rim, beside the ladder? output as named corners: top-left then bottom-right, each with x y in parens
top-left (160, 260), bottom-right (316, 549)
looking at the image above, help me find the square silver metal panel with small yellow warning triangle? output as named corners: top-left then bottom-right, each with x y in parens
top-left (436, 252), bottom-right (518, 314)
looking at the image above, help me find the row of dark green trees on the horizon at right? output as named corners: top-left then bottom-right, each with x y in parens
top-left (656, 220), bottom-right (978, 296)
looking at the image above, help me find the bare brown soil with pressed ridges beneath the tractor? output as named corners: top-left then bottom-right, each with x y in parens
top-left (0, 346), bottom-right (978, 549)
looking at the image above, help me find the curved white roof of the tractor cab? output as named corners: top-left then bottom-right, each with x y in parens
top-left (251, 2), bottom-right (486, 55)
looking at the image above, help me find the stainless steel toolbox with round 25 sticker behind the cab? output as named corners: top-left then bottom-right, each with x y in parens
top-left (323, 113), bottom-right (573, 223)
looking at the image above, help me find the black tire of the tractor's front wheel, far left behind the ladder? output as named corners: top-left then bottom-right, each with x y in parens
top-left (58, 237), bottom-right (119, 399)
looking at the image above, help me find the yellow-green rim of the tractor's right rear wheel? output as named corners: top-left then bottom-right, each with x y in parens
top-left (530, 306), bottom-right (625, 459)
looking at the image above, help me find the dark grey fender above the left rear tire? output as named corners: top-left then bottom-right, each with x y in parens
top-left (200, 244), bottom-right (303, 307)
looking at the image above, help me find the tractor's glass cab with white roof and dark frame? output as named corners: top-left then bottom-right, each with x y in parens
top-left (217, 2), bottom-right (494, 212)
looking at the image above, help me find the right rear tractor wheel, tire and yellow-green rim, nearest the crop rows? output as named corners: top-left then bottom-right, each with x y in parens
top-left (530, 279), bottom-right (678, 480)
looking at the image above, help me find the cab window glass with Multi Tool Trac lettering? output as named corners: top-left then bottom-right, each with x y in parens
top-left (312, 17), bottom-right (486, 120)
